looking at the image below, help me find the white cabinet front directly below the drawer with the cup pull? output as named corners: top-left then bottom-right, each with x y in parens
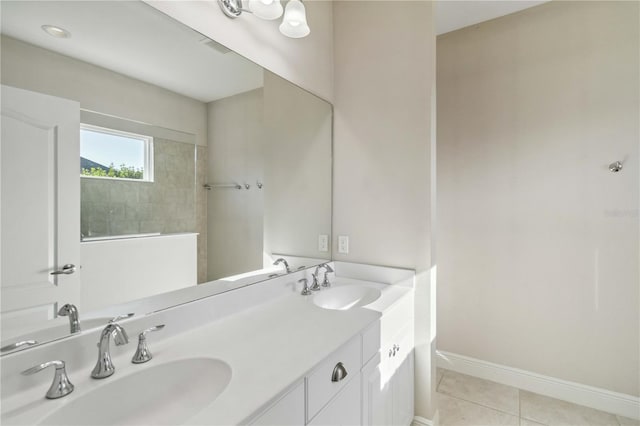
top-left (309, 373), bottom-right (361, 426)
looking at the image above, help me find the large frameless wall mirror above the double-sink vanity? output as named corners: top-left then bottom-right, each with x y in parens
top-left (0, 1), bottom-right (332, 354)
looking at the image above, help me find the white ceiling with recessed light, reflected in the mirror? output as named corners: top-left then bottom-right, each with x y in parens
top-left (0, 0), bottom-right (263, 102)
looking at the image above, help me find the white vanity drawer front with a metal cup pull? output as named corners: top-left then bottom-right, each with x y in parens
top-left (307, 335), bottom-right (362, 420)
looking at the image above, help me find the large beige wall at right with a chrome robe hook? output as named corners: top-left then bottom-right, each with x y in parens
top-left (437, 1), bottom-right (640, 396)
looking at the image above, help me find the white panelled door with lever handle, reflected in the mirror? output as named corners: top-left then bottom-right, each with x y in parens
top-left (0, 86), bottom-right (80, 340)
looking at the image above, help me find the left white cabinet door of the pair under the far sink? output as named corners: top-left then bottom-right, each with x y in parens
top-left (362, 362), bottom-right (393, 426)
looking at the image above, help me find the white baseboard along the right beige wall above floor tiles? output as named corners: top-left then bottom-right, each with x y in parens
top-left (436, 351), bottom-right (640, 419)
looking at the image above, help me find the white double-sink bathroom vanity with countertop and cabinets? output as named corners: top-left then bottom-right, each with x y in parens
top-left (0, 262), bottom-right (414, 425)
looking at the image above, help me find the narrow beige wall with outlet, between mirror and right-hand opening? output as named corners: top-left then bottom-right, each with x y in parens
top-left (333, 1), bottom-right (435, 418)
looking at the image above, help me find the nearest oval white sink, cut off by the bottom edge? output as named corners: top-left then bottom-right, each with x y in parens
top-left (40, 358), bottom-right (231, 426)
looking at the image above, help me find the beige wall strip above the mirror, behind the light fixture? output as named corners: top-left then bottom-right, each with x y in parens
top-left (146, 0), bottom-right (333, 101)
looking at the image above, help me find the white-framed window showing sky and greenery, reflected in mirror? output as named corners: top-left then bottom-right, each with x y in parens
top-left (80, 124), bottom-right (153, 182)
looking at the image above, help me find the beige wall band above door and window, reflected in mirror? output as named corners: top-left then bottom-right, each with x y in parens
top-left (2, 36), bottom-right (207, 145)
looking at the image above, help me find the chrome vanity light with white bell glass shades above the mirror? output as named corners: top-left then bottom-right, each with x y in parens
top-left (218, 0), bottom-right (311, 38)
